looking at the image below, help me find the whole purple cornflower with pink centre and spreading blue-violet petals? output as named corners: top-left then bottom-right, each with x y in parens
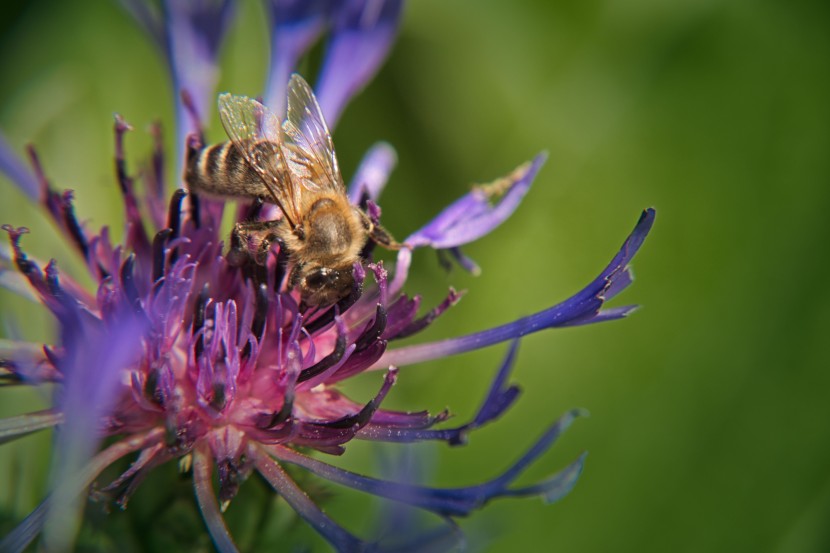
top-left (0, 0), bottom-right (654, 552)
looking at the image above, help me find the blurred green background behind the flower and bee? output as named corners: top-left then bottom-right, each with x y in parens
top-left (0, 0), bottom-right (830, 553)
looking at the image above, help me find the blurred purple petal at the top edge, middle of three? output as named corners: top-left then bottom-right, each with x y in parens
top-left (264, 0), bottom-right (332, 113)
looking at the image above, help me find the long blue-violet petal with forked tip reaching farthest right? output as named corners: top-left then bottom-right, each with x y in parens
top-left (370, 208), bottom-right (655, 370)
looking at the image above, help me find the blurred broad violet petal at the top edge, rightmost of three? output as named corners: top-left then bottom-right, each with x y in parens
top-left (317, 0), bottom-right (403, 128)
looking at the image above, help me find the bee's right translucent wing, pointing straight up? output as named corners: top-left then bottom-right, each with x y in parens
top-left (282, 74), bottom-right (346, 195)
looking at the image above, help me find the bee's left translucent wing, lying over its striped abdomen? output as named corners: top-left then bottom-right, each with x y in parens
top-left (219, 93), bottom-right (300, 227)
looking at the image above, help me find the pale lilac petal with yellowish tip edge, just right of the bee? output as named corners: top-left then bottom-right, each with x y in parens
top-left (404, 154), bottom-right (547, 249)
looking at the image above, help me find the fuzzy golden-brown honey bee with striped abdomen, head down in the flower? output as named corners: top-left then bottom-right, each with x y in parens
top-left (184, 74), bottom-right (401, 306)
